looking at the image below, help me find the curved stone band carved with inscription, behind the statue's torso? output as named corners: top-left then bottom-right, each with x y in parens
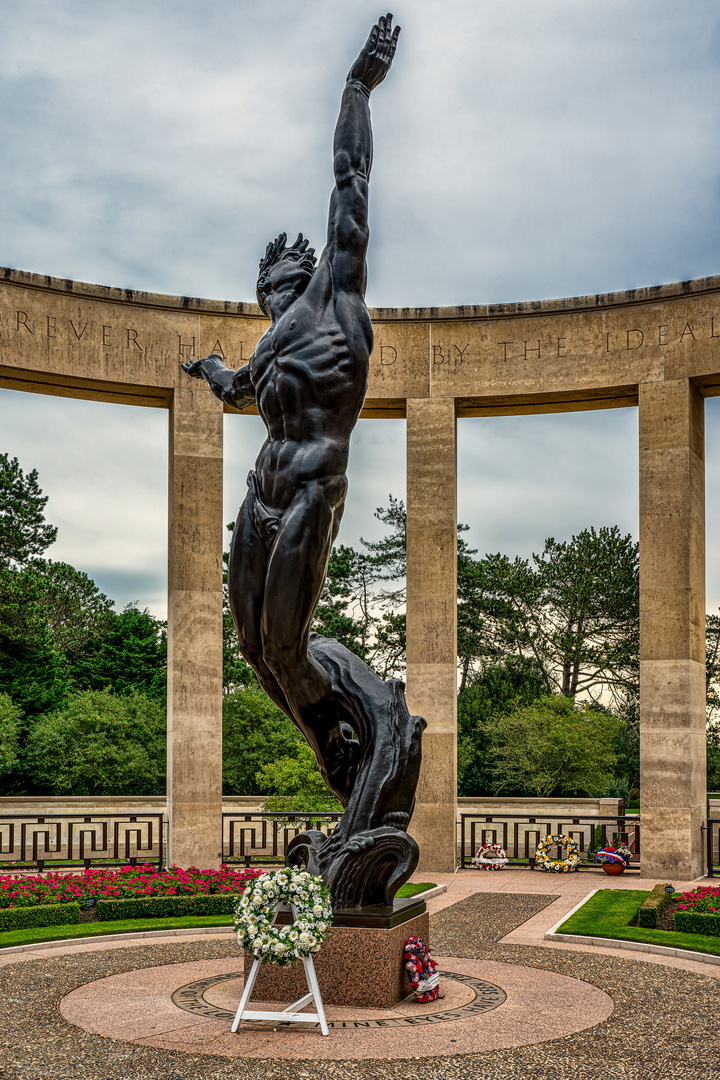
top-left (0, 286), bottom-right (720, 400)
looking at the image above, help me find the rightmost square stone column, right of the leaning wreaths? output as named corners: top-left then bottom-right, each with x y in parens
top-left (639, 379), bottom-right (706, 883)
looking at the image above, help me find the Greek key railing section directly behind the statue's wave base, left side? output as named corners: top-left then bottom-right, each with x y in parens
top-left (222, 812), bottom-right (342, 866)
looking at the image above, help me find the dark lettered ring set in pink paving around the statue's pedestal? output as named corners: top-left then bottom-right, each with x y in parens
top-left (171, 971), bottom-right (507, 1028)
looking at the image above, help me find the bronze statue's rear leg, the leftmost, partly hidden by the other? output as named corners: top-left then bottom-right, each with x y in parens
top-left (228, 499), bottom-right (297, 723)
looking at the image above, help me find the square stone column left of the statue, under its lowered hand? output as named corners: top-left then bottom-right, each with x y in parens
top-left (167, 379), bottom-right (222, 867)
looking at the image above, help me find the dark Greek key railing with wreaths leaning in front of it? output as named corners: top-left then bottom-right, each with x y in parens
top-left (460, 813), bottom-right (640, 870)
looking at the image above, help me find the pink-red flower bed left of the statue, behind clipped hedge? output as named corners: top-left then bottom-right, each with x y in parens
top-left (0, 863), bottom-right (263, 907)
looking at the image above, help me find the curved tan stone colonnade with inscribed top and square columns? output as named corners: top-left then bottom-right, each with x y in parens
top-left (0, 270), bottom-right (720, 880)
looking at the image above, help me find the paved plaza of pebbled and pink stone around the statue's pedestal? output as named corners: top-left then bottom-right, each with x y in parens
top-left (0, 870), bottom-right (720, 1080)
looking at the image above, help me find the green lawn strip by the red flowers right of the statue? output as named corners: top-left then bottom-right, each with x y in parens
top-left (557, 889), bottom-right (720, 956)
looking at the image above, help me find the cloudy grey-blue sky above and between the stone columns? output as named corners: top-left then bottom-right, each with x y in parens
top-left (0, 0), bottom-right (720, 615)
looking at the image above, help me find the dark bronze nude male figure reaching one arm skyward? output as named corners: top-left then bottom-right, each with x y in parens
top-left (182, 14), bottom-right (424, 911)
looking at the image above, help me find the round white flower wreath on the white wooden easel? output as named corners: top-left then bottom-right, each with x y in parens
top-left (235, 867), bottom-right (332, 964)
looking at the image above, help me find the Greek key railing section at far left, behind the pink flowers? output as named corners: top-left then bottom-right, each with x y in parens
top-left (0, 813), bottom-right (165, 873)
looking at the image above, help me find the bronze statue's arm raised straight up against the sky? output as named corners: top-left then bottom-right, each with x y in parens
top-left (324, 14), bottom-right (400, 295)
